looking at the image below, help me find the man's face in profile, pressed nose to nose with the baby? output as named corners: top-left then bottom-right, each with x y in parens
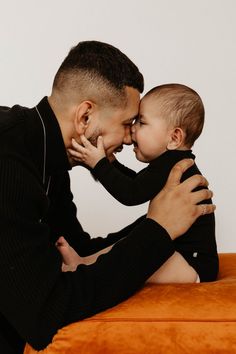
top-left (85, 87), bottom-right (140, 156)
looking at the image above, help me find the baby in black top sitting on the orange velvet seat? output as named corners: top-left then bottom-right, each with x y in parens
top-left (59, 84), bottom-right (218, 283)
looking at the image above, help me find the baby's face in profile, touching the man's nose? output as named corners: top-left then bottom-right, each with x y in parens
top-left (131, 96), bottom-right (171, 162)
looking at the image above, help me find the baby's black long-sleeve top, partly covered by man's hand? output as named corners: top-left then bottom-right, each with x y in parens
top-left (92, 150), bottom-right (219, 281)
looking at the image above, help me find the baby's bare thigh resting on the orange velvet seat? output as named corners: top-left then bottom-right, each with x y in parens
top-left (147, 252), bottom-right (198, 284)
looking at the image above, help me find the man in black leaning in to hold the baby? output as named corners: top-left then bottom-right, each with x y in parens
top-left (0, 41), bottom-right (214, 353)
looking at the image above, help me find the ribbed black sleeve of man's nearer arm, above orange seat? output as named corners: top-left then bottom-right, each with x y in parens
top-left (0, 158), bottom-right (174, 350)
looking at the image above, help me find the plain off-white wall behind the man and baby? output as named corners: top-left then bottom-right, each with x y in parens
top-left (0, 0), bottom-right (236, 252)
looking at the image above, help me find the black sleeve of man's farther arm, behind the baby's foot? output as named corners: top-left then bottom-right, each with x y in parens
top-left (45, 172), bottom-right (148, 256)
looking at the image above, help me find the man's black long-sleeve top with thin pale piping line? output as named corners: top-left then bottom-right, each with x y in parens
top-left (0, 97), bottom-right (174, 354)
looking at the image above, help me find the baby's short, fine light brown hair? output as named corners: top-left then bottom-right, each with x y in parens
top-left (145, 84), bottom-right (205, 148)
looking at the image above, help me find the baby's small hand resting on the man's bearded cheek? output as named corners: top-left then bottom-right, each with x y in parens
top-left (68, 135), bottom-right (106, 168)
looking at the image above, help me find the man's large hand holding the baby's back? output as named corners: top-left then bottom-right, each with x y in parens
top-left (147, 159), bottom-right (215, 239)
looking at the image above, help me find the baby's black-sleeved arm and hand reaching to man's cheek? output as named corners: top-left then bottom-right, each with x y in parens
top-left (69, 136), bottom-right (161, 205)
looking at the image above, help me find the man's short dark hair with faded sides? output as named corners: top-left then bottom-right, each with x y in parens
top-left (53, 41), bottom-right (144, 106)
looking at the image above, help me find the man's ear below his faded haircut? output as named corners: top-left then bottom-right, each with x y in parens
top-left (74, 101), bottom-right (93, 135)
